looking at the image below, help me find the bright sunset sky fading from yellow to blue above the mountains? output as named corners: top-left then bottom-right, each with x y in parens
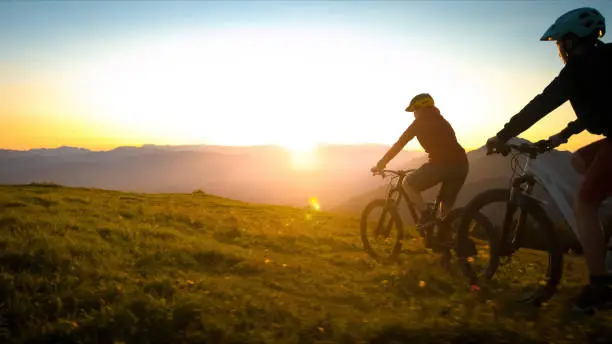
top-left (0, 0), bottom-right (612, 150)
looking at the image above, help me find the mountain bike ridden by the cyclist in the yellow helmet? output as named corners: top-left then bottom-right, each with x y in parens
top-left (361, 169), bottom-right (492, 266)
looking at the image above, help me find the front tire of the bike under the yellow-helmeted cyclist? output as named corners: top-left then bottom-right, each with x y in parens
top-left (360, 199), bottom-right (404, 264)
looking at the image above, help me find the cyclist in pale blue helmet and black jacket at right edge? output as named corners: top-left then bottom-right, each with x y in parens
top-left (487, 7), bottom-right (612, 312)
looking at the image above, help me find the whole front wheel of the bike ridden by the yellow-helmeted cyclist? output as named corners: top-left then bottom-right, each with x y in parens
top-left (361, 199), bottom-right (404, 264)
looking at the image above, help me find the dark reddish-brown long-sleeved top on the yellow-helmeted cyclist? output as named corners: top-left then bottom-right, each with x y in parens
top-left (379, 107), bottom-right (467, 165)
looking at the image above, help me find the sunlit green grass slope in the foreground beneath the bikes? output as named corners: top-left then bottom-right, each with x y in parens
top-left (0, 184), bottom-right (612, 343)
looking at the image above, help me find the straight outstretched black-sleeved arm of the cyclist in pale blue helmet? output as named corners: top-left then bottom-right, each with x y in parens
top-left (497, 70), bottom-right (570, 142)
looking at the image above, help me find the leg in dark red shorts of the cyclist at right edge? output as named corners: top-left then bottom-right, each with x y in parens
top-left (572, 139), bottom-right (612, 310)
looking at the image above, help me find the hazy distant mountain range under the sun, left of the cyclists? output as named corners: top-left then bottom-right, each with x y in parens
top-left (0, 145), bottom-right (424, 209)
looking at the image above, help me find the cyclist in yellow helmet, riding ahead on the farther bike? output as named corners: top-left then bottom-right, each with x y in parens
top-left (372, 93), bottom-right (469, 248)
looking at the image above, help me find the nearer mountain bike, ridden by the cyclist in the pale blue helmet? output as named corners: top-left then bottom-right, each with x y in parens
top-left (456, 141), bottom-right (564, 306)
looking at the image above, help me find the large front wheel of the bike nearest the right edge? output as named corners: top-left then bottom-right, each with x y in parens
top-left (457, 189), bottom-right (563, 306)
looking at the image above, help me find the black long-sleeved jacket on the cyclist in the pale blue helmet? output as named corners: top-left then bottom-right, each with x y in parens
top-left (497, 42), bottom-right (612, 141)
